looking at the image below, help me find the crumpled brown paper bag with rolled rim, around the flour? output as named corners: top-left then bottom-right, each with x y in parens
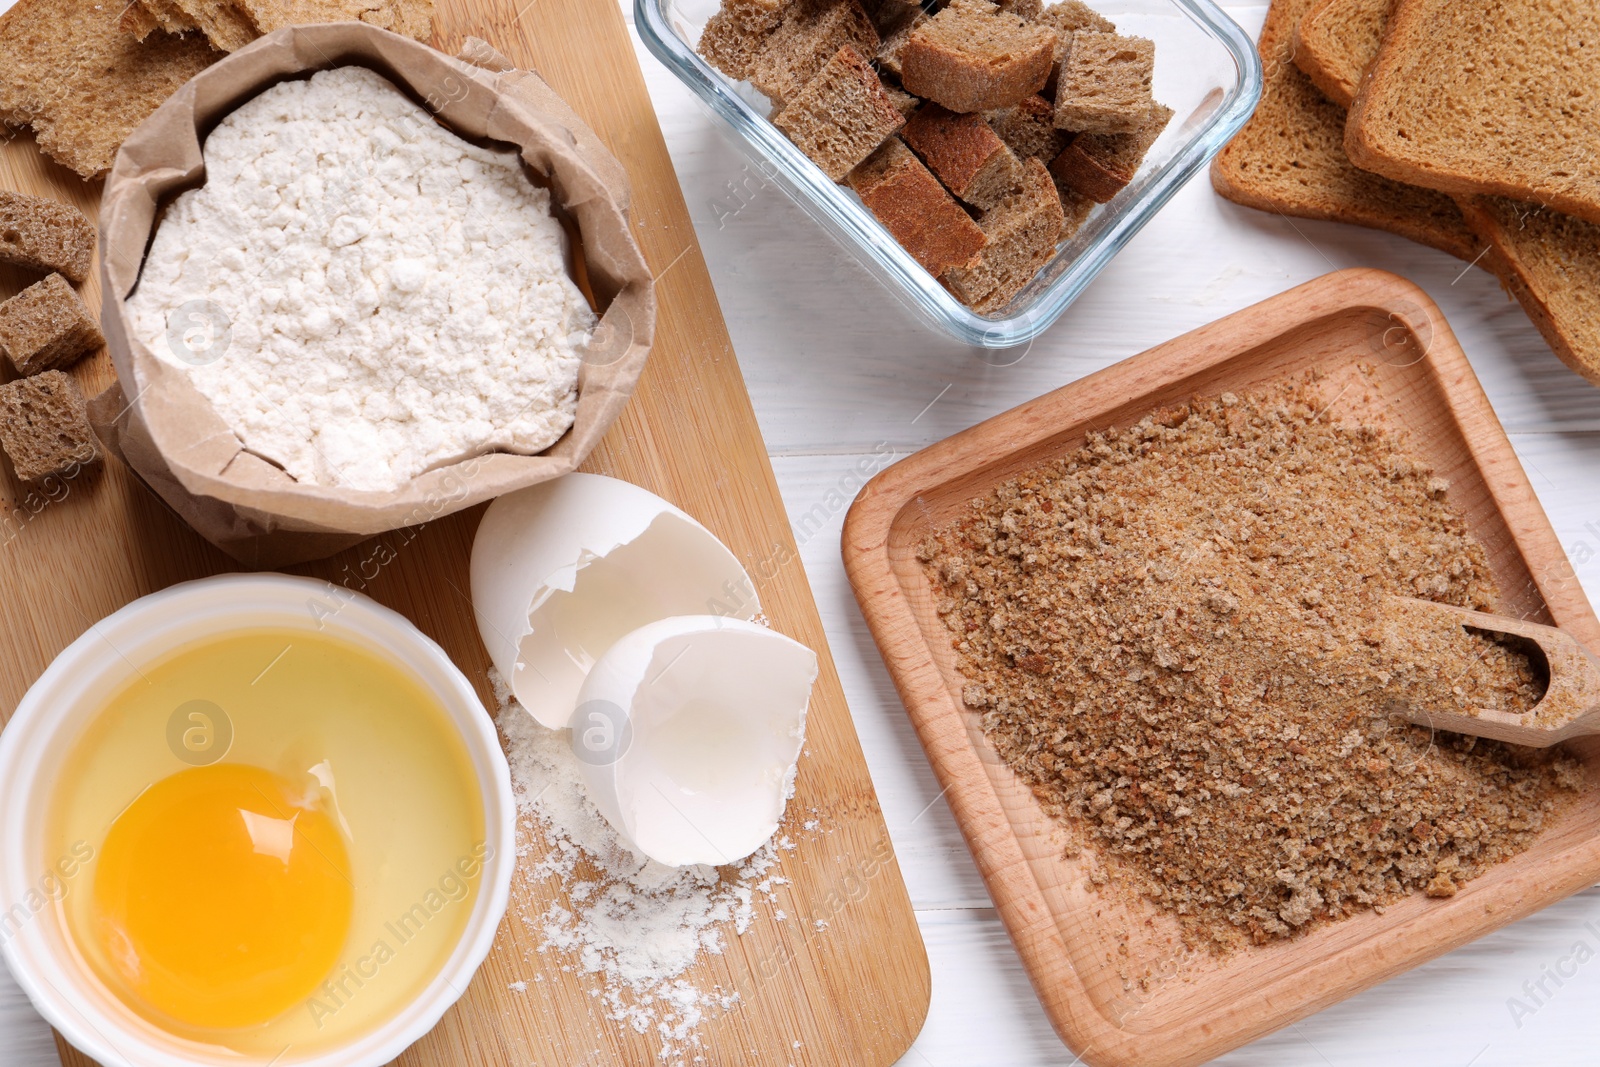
top-left (98, 22), bottom-right (654, 566)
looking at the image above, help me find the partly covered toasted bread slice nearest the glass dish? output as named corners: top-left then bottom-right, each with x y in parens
top-left (1211, 0), bottom-right (1483, 261)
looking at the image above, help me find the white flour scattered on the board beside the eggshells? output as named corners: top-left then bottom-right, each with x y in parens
top-left (490, 670), bottom-right (812, 1062)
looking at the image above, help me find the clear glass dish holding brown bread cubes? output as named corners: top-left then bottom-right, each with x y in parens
top-left (634, 0), bottom-right (1261, 349)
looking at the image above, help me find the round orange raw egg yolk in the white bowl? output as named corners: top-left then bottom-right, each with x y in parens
top-left (94, 763), bottom-right (352, 1030)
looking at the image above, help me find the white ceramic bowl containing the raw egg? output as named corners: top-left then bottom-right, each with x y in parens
top-left (0, 574), bottom-right (515, 1067)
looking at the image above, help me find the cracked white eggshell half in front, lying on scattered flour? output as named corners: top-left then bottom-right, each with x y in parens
top-left (571, 616), bottom-right (818, 867)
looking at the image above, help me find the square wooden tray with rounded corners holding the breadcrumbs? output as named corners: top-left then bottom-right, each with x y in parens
top-left (843, 270), bottom-right (1600, 1067)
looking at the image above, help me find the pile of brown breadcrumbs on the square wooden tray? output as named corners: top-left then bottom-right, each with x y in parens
top-left (920, 381), bottom-right (1582, 952)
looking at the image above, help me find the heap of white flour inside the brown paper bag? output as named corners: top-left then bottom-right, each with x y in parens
top-left (128, 67), bottom-right (594, 490)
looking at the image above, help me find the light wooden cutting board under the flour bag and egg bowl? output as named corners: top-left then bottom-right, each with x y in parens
top-left (0, 0), bottom-right (930, 1067)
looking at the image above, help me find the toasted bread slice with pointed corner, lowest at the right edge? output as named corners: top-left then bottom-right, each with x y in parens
top-left (1461, 197), bottom-right (1600, 386)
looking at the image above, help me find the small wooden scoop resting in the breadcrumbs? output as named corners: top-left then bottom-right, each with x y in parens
top-left (1389, 597), bottom-right (1600, 749)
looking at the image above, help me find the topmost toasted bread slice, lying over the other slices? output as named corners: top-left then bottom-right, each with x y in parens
top-left (1344, 0), bottom-right (1600, 222)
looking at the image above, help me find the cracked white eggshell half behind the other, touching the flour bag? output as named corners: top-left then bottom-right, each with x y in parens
top-left (472, 474), bottom-right (762, 729)
